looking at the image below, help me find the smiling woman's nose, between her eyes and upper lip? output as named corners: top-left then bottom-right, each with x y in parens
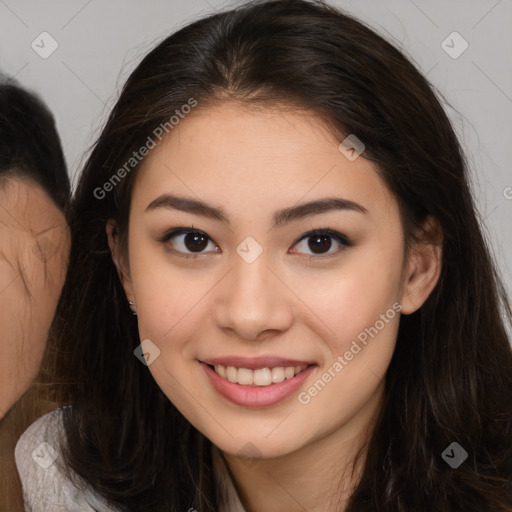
top-left (214, 253), bottom-right (293, 340)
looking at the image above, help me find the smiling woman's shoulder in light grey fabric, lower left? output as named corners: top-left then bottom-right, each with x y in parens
top-left (14, 408), bottom-right (118, 512)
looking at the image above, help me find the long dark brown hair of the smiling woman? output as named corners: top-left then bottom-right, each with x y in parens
top-left (48, 0), bottom-right (512, 512)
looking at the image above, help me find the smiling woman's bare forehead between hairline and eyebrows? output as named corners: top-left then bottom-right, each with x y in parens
top-left (132, 103), bottom-right (397, 220)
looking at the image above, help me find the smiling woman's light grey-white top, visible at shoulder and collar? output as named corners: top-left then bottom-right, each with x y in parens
top-left (15, 409), bottom-right (246, 512)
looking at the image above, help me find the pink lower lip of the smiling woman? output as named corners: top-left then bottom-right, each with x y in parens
top-left (199, 361), bottom-right (316, 407)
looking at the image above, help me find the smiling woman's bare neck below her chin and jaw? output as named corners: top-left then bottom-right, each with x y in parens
top-left (222, 381), bottom-right (384, 512)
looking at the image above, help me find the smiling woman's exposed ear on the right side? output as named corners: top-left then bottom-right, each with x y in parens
top-left (400, 216), bottom-right (443, 315)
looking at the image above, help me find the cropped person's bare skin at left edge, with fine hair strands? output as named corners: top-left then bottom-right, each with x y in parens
top-left (0, 178), bottom-right (70, 417)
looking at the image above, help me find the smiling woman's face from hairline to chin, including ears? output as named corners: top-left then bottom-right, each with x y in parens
top-left (107, 104), bottom-right (437, 457)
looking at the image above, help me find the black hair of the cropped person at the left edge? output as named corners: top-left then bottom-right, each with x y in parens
top-left (0, 77), bottom-right (71, 213)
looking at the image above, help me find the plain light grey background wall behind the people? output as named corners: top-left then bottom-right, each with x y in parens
top-left (0, 0), bottom-right (512, 308)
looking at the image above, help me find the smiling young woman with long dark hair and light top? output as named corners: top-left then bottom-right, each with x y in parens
top-left (17, 0), bottom-right (512, 512)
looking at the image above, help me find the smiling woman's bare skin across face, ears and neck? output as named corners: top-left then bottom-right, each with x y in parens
top-left (107, 103), bottom-right (441, 512)
